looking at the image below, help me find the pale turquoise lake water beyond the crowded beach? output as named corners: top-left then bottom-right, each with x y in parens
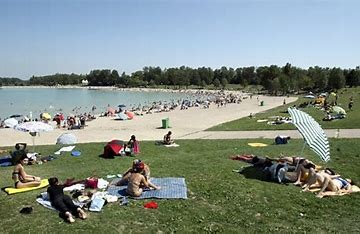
top-left (0, 88), bottom-right (196, 119)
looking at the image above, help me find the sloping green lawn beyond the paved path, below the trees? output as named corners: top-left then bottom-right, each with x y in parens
top-left (208, 88), bottom-right (360, 131)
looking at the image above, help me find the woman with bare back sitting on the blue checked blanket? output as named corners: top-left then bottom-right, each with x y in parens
top-left (126, 162), bottom-right (160, 197)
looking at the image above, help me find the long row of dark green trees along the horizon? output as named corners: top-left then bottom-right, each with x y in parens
top-left (0, 63), bottom-right (360, 94)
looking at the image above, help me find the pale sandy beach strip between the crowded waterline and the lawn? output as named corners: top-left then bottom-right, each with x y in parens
top-left (0, 96), bottom-right (296, 146)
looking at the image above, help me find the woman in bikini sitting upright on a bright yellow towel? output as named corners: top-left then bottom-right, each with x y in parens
top-left (12, 154), bottom-right (41, 188)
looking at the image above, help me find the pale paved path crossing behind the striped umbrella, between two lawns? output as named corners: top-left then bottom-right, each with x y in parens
top-left (176, 129), bottom-right (360, 139)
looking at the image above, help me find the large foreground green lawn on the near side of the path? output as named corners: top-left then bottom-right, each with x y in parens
top-left (0, 139), bottom-right (360, 233)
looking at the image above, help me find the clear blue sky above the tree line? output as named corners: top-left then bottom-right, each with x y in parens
top-left (0, 0), bottom-right (360, 79)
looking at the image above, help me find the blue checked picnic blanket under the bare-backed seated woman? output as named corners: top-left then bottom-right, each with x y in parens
top-left (107, 177), bottom-right (187, 199)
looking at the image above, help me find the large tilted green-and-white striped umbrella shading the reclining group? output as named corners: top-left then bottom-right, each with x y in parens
top-left (288, 107), bottom-right (330, 162)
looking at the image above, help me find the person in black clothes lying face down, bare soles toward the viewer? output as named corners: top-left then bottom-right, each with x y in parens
top-left (47, 177), bottom-right (87, 223)
